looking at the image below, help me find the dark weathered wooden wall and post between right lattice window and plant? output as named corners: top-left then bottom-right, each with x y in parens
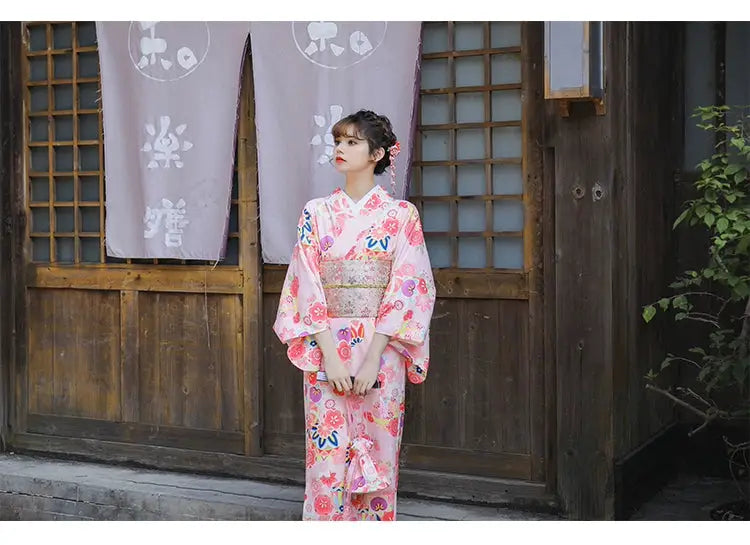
top-left (545, 23), bottom-right (682, 519)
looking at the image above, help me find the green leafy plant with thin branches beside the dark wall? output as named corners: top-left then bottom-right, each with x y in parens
top-left (643, 106), bottom-right (750, 435)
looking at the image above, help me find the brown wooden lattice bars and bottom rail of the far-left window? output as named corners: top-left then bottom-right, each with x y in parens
top-left (21, 21), bottom-right (241, 276)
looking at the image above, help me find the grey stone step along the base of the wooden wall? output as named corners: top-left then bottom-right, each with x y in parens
top-left (0, 454), bottom-right (558, 521)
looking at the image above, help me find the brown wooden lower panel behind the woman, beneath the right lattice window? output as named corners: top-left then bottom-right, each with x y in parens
top-left (263, 293), bottom-right (534, 480)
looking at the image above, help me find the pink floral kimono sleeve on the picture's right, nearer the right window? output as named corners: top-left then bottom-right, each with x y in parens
top-left (375, 201), bottom-right (435, 384)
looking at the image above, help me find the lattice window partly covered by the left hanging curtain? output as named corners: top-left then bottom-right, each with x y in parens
top-left (24, 22), bottom-right (240, 266)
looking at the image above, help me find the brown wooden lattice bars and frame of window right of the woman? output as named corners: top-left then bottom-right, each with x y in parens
top-left (263, 21), bottom-right (543, 300)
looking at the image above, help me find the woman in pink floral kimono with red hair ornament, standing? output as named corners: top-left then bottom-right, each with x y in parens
top-left (274, 110), bottom-right (435, 520)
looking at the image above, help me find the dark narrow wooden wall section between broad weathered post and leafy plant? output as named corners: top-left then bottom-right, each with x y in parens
top-left (614, 23), bottom-right (684, 458)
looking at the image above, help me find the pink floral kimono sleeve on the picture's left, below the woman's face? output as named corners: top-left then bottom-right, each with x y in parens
top-left (273, 202), bottom-right (328, 371)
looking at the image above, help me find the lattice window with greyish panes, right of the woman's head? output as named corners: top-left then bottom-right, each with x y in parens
top-left (411, 22), bottom-right (524, 270)
